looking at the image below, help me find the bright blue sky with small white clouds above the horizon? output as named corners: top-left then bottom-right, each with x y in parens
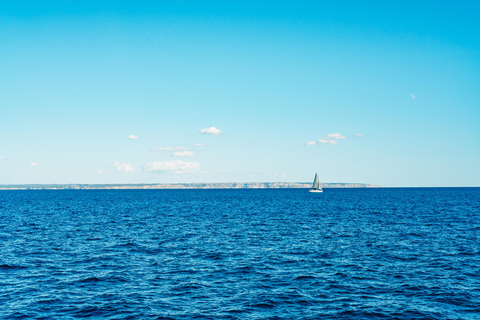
top-left (0, 0), bottom-right (480, 187)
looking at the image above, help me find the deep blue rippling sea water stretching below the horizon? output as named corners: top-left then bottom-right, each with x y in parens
top-left (0, 188), bottom-right (480, 319)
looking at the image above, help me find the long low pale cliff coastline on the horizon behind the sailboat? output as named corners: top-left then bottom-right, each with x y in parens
top-left (0, 182), bottom-right (382, 190)
